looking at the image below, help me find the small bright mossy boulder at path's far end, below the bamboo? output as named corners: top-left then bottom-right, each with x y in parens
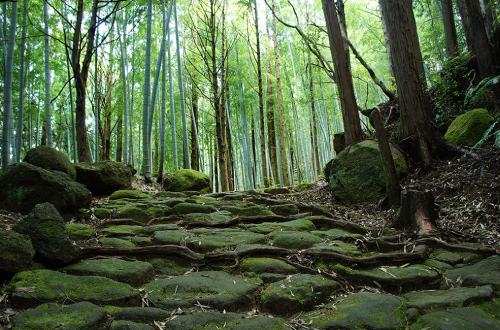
top-left (163, 169), bottom-right (210, 194)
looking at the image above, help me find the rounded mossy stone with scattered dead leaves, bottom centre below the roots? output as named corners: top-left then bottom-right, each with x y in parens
top-left (260, 274), bottom-right (340, 316)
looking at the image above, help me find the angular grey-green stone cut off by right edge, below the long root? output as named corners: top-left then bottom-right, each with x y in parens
top-left (445, 255), bottom-right (500, 293)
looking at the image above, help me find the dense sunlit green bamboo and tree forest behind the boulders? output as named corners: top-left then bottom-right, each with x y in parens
top-left (0, 0), bottom-right (498, 191)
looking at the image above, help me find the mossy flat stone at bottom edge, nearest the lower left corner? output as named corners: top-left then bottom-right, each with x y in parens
top-left (12, 302), bottom-right (108, 330)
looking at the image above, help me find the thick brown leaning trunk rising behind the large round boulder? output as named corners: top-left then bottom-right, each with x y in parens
top-left (322, 0), bottom-right (363, 146)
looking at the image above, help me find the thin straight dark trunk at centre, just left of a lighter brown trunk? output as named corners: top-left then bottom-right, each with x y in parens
top-left (252, 0), bottom-right (269, 187)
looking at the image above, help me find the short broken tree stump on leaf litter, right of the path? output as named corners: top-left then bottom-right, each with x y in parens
top-left (394, 190), bottom-right (439, 236)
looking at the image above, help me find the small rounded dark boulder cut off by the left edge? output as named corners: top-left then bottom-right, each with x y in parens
top-left (0, 229), bottom-right (35, 274)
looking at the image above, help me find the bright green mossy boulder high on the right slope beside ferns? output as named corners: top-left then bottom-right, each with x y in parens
top-left (444, 109), bottom-right (494, 147)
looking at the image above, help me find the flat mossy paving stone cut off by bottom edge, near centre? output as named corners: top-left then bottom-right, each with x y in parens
top-left (165, 312), bottom-right (292, 330)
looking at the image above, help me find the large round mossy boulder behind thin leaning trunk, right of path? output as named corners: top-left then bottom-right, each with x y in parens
top-left (328, 140), bottom-right (407, 204)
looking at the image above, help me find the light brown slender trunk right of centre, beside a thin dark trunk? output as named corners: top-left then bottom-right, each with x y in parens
top-left (271, 0), bottom-right (292, 186)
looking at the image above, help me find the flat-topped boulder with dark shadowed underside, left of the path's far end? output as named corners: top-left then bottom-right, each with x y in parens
top-left (75, 160), bottom-right (137, 196)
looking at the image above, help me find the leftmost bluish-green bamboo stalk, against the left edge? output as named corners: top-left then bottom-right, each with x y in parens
top-left (2, 2), bottom-right (17, 170)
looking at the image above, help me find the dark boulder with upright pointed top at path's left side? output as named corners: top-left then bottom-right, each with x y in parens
top-left (12, 203), bottom-right (81, 264)
